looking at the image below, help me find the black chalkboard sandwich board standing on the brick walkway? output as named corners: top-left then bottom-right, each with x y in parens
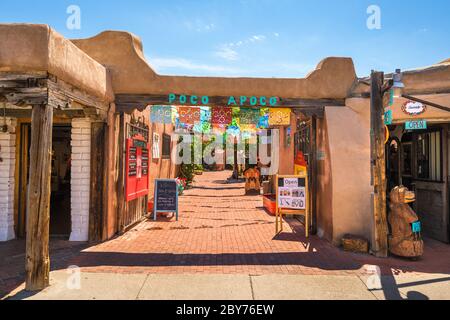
top-left (153, 179), bottom-right (178, 221)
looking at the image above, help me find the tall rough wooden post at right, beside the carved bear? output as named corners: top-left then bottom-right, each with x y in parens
top-left (370, 71), bottom-right (388, 258)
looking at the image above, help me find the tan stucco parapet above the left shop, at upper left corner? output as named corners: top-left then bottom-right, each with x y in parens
top-left (0, 24), bottom-right (114, 101)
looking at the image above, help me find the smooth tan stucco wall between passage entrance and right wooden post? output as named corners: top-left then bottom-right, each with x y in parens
top-left (325, 99), bottom-right (373, 244)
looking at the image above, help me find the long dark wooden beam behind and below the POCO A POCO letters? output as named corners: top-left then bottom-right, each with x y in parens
top-left (115, 94), bottom-right (345, 113)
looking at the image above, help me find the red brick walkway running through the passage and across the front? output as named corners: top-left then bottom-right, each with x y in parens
top-left (0, 172), bottom-right (450, 294)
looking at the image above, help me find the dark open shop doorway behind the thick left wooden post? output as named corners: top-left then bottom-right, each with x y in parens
top-left (16, 123), bottom-right (71, 239)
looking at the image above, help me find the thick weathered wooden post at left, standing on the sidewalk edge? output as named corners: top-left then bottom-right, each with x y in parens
top-left (25, 105), bottom-right (53, 291)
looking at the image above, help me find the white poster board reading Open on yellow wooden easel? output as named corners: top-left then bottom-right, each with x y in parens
top-left (277, 178), bottom-right (307, 210)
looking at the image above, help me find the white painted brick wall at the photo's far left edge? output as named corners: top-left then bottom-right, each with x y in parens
top-left (0, 118), bottom-right (17, 241)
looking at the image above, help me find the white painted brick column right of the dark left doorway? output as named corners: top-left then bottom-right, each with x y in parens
top-left (70, 119), bottom-right (91, 241)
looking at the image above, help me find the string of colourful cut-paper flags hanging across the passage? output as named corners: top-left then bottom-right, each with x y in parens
top-left (150, 106), bottom-right (291, 135)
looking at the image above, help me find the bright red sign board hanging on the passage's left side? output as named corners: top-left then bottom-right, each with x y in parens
top-left (125, 137), bottom-right (149, 202)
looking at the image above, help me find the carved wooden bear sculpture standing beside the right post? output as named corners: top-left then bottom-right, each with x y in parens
top-left (389, 186), bottom-right (423, 258)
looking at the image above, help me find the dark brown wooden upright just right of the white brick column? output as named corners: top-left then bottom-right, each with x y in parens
top-left (89, 122), bottom-right (106, 242)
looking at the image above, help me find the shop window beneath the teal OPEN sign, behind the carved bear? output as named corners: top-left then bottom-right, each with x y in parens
top-left (416, 131), bottom-right (442, 181)
